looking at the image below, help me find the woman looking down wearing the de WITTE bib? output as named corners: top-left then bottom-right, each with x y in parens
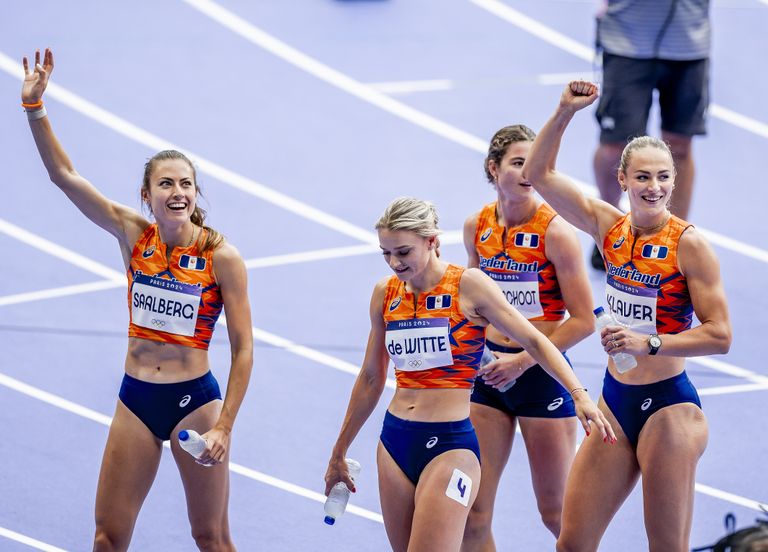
top-left (325, 198), bottom-right (613, 552)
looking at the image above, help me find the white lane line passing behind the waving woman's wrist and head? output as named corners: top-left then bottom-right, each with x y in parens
top-left (0, 52), bottom-right (378, 243)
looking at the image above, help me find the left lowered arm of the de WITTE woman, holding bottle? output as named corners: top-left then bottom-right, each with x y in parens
top-left (325, 279), bottom-right (389, 495)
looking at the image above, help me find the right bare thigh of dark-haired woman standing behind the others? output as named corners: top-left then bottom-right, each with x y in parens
top-left (520, 417), bottom-right (577, 506)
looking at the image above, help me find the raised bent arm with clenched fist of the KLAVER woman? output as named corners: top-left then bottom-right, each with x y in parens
top-left (523, 81), bottom-right (622, 245)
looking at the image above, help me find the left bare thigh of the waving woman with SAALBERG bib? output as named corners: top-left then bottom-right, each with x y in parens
top-left (96, 400), bottom-right (162, 533)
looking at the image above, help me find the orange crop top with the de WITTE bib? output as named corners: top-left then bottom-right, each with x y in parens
top-left (383, 265), bottom-right (485, 389)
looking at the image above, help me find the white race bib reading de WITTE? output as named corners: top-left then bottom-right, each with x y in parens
top-left (384, 318), bottom-right (453, 372)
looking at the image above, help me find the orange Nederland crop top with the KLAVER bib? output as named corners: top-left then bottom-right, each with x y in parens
top-left (603, 214), bottom-right (693, 334)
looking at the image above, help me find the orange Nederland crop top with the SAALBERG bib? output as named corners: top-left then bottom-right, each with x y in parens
top-left (127, 224), bottom-right (223, 350)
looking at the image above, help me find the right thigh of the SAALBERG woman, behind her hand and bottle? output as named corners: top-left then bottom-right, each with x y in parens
top-left (171, 400), bottom-right (232, 533)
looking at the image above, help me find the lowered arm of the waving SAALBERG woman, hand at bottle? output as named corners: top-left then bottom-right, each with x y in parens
top-left (200, 242), bottom-right (253, 463)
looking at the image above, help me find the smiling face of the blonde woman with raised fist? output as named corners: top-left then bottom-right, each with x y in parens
top-left (619, 145), bottom-right (675, 219)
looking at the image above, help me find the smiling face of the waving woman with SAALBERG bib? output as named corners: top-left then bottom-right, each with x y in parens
top-left (142, 159), bottom-right (197, 222)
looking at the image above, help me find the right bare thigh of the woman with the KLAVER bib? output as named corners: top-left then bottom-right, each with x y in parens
top-left (637, 403), bottom-right (708, 550)
